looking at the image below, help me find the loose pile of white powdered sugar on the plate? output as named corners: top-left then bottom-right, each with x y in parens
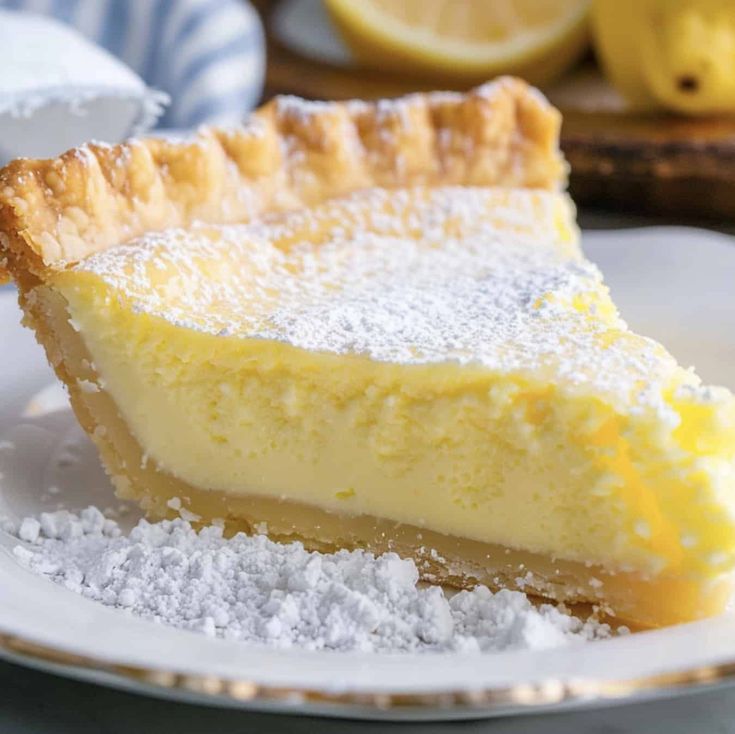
top-left (12, 507), bottom-right (612, 652)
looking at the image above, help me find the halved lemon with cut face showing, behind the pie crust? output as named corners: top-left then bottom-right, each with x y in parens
top-left (324, 0), bottom-right (590, 84)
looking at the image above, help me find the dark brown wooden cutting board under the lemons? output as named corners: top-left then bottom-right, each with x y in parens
top-left (256, 0), bottom-right (735, 224)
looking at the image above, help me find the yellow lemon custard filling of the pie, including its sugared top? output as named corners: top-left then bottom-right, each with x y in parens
top-left (53, 187), bottom-right (735, 592)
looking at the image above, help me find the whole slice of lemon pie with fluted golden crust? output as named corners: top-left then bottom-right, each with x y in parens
top-left (0, 79), bottom-right (735, 625)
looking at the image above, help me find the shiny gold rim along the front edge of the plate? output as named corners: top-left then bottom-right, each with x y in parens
top-left (0, 632), bottom-right (735, 717)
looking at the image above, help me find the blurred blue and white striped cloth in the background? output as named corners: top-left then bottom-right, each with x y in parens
top-left (0, 0), bottom-right (265, 128)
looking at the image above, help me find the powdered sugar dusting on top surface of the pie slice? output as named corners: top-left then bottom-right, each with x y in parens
top-left (77, 187), bottom-right (675, 410)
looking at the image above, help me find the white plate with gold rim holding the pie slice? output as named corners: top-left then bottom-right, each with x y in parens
top-left (0, 228), bottom-right (735, 719)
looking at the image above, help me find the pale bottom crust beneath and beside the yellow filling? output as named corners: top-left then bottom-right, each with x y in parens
top-left (20, 286), bottom-right (732, 627)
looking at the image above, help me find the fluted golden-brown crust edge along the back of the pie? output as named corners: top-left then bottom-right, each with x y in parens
top-left (0, 78), bottom-right (566, 287)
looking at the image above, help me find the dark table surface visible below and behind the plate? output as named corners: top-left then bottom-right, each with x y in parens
top-left (0, 211), bottom-right (735, 734)
